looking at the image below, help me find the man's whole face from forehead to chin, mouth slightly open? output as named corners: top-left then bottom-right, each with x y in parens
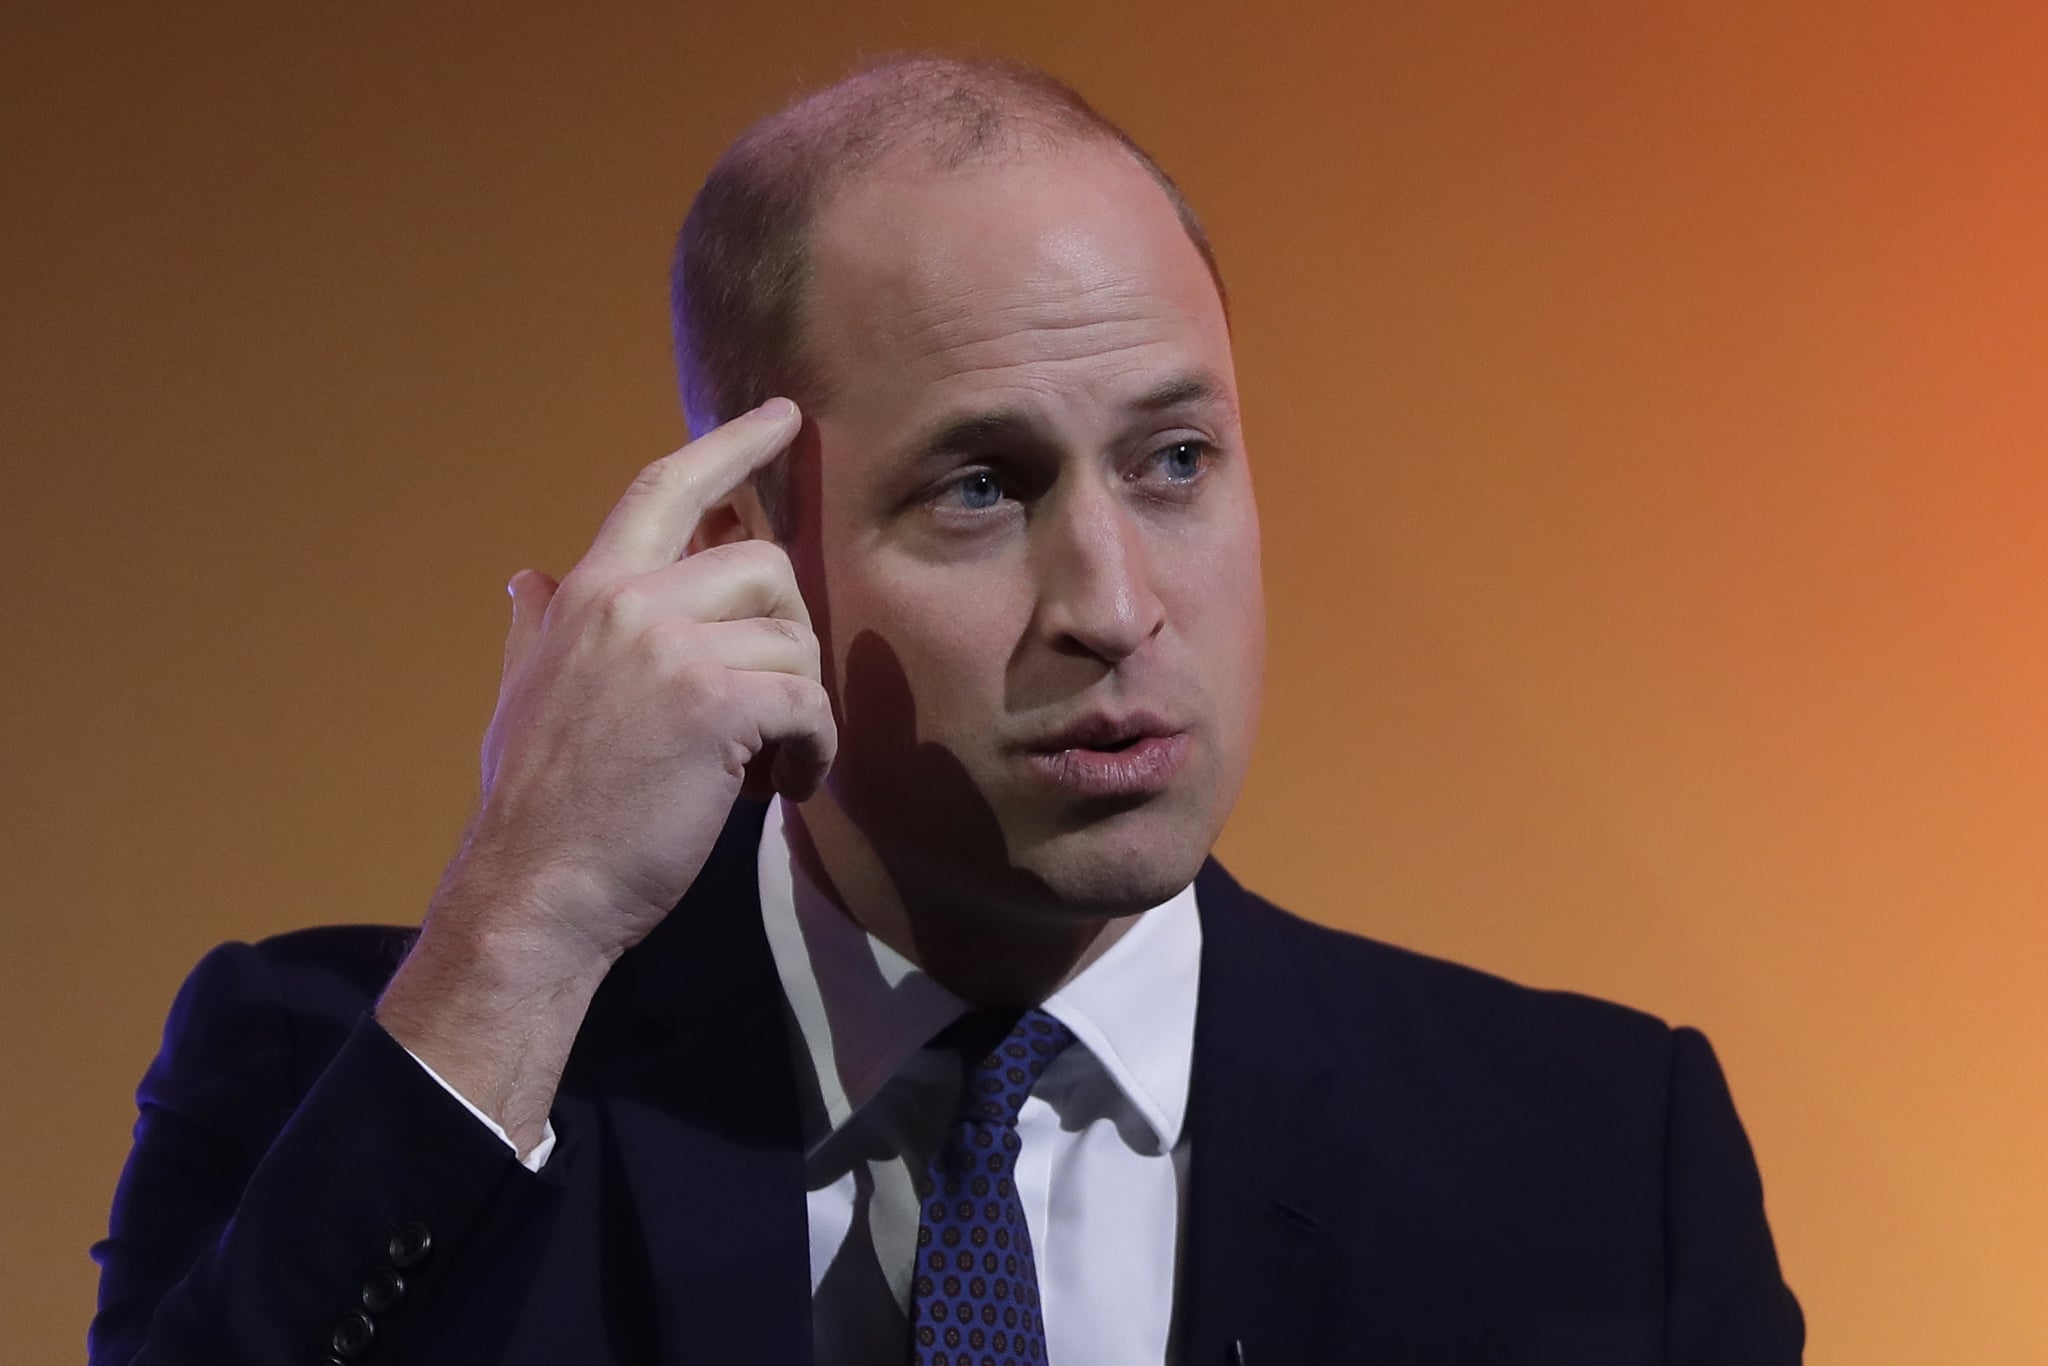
top-left (793, 143), bottom-right (1266, 915)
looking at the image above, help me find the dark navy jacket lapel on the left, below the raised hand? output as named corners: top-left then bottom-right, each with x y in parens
top-left (586, 803), bottom-right (811, 1366)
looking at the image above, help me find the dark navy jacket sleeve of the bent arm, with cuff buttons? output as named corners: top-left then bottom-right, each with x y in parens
top-left (90, 944), bottom-right (555, 1366)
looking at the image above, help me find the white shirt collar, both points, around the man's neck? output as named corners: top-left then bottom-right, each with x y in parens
top-left (760, 799), bottom-right (1202, 1151)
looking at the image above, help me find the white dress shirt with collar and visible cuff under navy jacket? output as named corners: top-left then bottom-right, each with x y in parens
top-left (420, 799), bottom-right (1202, 1366)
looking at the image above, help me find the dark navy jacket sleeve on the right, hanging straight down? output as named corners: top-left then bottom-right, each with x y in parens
top-left (1665, 1028), bottom-right (1804, 1366)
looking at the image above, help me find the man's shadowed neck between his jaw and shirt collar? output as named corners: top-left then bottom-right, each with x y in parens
top-left (784, 791), bottom-right (1137, 1006)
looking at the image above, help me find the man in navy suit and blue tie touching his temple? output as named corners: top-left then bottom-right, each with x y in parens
top-left (92, 61), bottom-right (1802, 1366)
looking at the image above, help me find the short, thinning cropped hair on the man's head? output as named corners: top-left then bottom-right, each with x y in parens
top-left (670, 57), bottom-right (1223, 530)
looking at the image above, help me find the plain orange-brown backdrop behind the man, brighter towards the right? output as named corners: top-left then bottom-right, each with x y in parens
top-left (0, 0), bottom-right (2048, 1364)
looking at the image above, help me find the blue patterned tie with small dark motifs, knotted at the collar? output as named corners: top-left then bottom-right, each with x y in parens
top-left (909, 1010), bottom-right (1073, 1366)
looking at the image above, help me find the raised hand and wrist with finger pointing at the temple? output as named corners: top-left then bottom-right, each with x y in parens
top-left (377, 399), bottom-right (836, 1151)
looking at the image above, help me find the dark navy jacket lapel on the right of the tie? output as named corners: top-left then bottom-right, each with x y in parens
top-left (1180, 860), bottom-right (1358, 1366)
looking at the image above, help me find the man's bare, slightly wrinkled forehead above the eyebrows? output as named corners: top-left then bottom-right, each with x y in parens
top-left (805, 143), bottom-right (1231, 420)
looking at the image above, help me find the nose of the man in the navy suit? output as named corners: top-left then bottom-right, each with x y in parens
top-left (1032, 481), bottom-right (1165, 666)
